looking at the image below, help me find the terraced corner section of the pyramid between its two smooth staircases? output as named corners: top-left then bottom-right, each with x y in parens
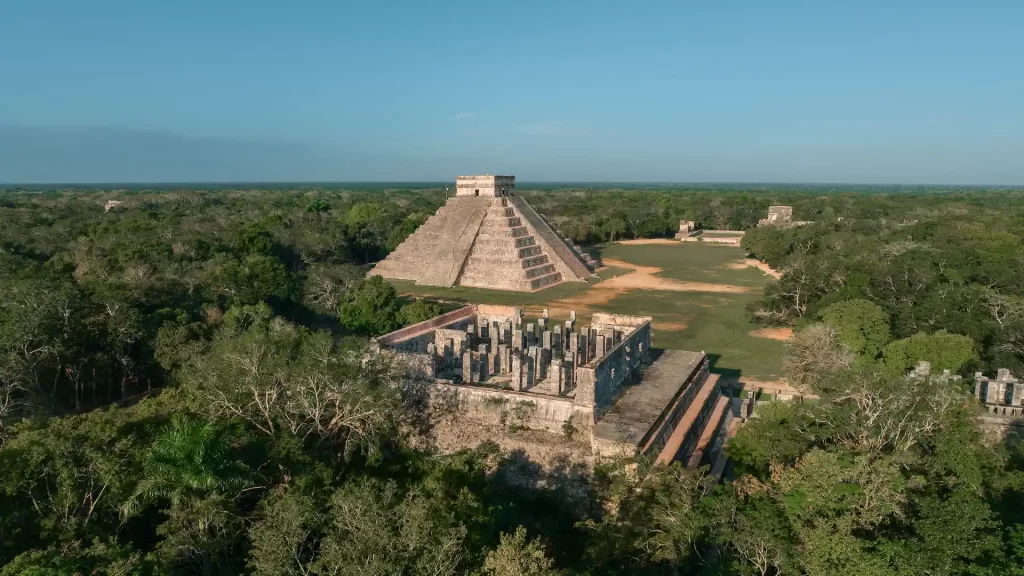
top-left (457, 198), bottom-right (562, 291)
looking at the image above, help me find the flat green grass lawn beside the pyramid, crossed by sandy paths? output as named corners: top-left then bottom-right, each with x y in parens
top-left (392, 243), bottom-right (782, 380)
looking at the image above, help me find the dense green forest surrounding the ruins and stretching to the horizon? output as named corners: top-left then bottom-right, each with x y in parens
top-left (0, 189), bottom-right (1024, 576)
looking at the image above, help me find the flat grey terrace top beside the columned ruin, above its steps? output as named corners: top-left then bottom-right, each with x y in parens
top-left (594, 351), bottom-right (707, 454)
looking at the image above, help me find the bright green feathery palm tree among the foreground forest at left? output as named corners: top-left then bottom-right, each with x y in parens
top-left (121, 414), bottom-right (254, 520)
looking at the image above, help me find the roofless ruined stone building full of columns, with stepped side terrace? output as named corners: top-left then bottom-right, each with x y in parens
top-left (376, 304), bottom-right (734, 474)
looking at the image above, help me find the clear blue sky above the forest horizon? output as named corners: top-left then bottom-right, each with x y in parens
top-left (0, 0), bottom-right (1024, 184)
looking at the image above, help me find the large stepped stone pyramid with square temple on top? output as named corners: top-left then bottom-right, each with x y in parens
top-left (370, 174), bottom-right (595, 292)
